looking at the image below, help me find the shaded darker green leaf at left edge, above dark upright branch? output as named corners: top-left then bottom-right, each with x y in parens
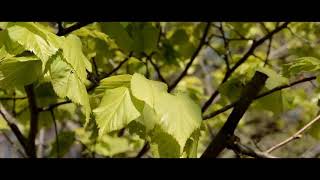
top-left (0, 57), bottom-right (41, 88)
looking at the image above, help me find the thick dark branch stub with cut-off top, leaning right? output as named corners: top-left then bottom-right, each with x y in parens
top-left (201, 71), bottom-right (268, 158)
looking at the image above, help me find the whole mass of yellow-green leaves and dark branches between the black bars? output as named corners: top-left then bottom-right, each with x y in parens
top-left (0, 22), bottom-right (320, 158)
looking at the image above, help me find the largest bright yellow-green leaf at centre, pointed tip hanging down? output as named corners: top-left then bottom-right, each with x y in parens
top-left (131, 73), bottom-right (202, 152)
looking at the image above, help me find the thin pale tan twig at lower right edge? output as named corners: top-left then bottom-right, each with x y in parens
top-left (266, 112), bottom-right (320, 153)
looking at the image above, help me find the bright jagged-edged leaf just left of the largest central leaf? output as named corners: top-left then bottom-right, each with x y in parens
top-left (93, 87), bottom-right (140, 137)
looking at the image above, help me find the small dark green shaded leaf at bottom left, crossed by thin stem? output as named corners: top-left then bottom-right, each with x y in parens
top-left (49, 131), bottom-right (75, 157)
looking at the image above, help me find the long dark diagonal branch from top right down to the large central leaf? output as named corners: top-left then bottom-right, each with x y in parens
top-left (202, 22), bottom-right (289, 112)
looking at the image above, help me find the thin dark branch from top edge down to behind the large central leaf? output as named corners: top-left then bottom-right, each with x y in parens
top-left (168, 23), bottom-right (211, 92)
